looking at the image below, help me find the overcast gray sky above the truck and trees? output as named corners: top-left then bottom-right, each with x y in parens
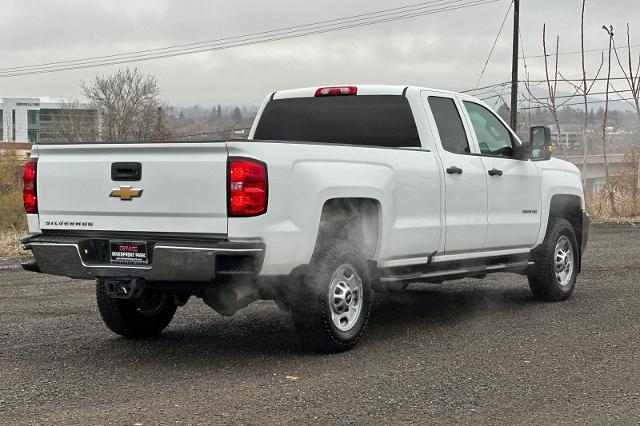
top-left (0, 0), bottom-right (640, 106)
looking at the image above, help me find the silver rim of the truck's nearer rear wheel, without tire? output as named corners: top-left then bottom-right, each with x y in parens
top-left (328, 264), bottom-right (362, 331)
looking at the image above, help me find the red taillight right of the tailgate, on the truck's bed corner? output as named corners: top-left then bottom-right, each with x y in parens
top-left (228, 159), bottom-right (267, 216)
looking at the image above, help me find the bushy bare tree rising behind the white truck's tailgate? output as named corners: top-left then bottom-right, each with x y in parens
top-left (81, 68), bottom-right (168, 141)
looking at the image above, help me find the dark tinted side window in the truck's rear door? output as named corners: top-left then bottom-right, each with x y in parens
top-left (429, 96), bottom-right (471, 154)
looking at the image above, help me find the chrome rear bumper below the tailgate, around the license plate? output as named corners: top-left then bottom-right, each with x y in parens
top-left (22, 234), bottom-right (265, 282)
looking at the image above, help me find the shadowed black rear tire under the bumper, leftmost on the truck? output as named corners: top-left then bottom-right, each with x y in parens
top-left (96, 280), bottom-right (178, 338)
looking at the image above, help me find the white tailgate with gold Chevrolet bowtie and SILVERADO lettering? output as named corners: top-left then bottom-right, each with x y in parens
top-left (37, 142), bottom-right (227, 234)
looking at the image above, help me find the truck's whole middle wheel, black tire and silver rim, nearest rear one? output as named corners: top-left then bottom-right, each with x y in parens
top-left (292, 241), bottom-right (372, 352)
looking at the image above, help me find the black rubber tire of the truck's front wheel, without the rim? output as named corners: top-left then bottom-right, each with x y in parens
top-left (528, 217), bottom-right (579, 302)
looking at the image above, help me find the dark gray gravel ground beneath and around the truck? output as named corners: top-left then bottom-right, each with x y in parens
top-left (0, 226), bottom-right (640, 424)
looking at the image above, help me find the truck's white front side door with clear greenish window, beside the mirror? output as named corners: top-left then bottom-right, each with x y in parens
top-left (463, 100), bottom-right (540, 250)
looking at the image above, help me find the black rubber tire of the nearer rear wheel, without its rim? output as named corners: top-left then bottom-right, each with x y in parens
top-left (292, 240), bottom-right (373, 353)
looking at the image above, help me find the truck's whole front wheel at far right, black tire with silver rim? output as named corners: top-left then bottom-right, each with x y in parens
top-left (529, 217), bottom-right (579, 302)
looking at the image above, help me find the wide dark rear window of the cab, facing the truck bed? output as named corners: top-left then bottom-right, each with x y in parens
top-left (254, 95), bottom-right (421, 148)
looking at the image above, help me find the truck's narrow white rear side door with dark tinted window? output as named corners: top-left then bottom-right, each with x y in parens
top-left (422, 92), bottom-right (487, 253)
